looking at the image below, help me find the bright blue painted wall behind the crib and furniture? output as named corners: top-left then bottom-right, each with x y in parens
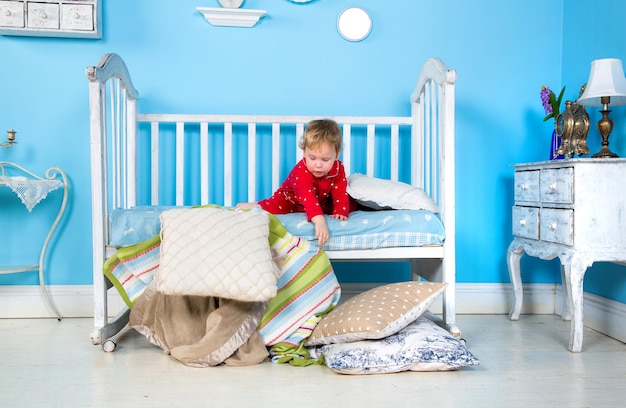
top-left (0, 0), bottom-right (626, 301)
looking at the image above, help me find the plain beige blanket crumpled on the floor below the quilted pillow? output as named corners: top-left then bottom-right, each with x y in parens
top-left (130, 281), bottom-right (268, 367)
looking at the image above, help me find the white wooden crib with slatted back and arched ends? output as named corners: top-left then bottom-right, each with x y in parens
top-left (86, 54), bottom-right (459, 344)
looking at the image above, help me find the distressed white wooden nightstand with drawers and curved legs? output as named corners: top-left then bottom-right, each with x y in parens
top-left (507, 159), bottom-right (626, 352)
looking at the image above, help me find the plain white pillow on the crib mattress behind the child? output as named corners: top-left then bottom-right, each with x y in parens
top-left (347, 174), bottom-right (439, 213)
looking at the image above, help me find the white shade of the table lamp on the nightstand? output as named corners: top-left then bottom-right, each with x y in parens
top-left (577, 58), bottom-right (626, 106)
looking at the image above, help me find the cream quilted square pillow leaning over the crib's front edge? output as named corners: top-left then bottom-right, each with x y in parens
top-left (156, 208), bottom-right (278, 302)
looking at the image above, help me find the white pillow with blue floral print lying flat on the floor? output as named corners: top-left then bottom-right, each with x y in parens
top-left (316, 316), bottom-right (480, 374)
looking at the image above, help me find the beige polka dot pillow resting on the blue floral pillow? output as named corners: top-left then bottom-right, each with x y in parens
top-left (305, 281), bottom-right (447, 347)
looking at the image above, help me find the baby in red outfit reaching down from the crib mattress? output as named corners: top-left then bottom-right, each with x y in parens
top-left (237, 119), bottom-right (357, 247)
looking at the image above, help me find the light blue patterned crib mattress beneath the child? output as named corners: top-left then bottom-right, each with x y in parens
top-left (109, 206), bottom-right (445, 251)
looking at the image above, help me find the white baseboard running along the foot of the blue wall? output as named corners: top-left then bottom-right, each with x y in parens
top-left (0, 283), bottom-right (626, 342)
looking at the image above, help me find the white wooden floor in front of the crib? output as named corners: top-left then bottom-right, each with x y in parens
top-left (0, 315), bottom-right (626, 408)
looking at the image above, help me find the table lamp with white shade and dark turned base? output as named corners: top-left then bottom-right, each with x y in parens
top-left (577, 58), bottom-right (626, 158)
